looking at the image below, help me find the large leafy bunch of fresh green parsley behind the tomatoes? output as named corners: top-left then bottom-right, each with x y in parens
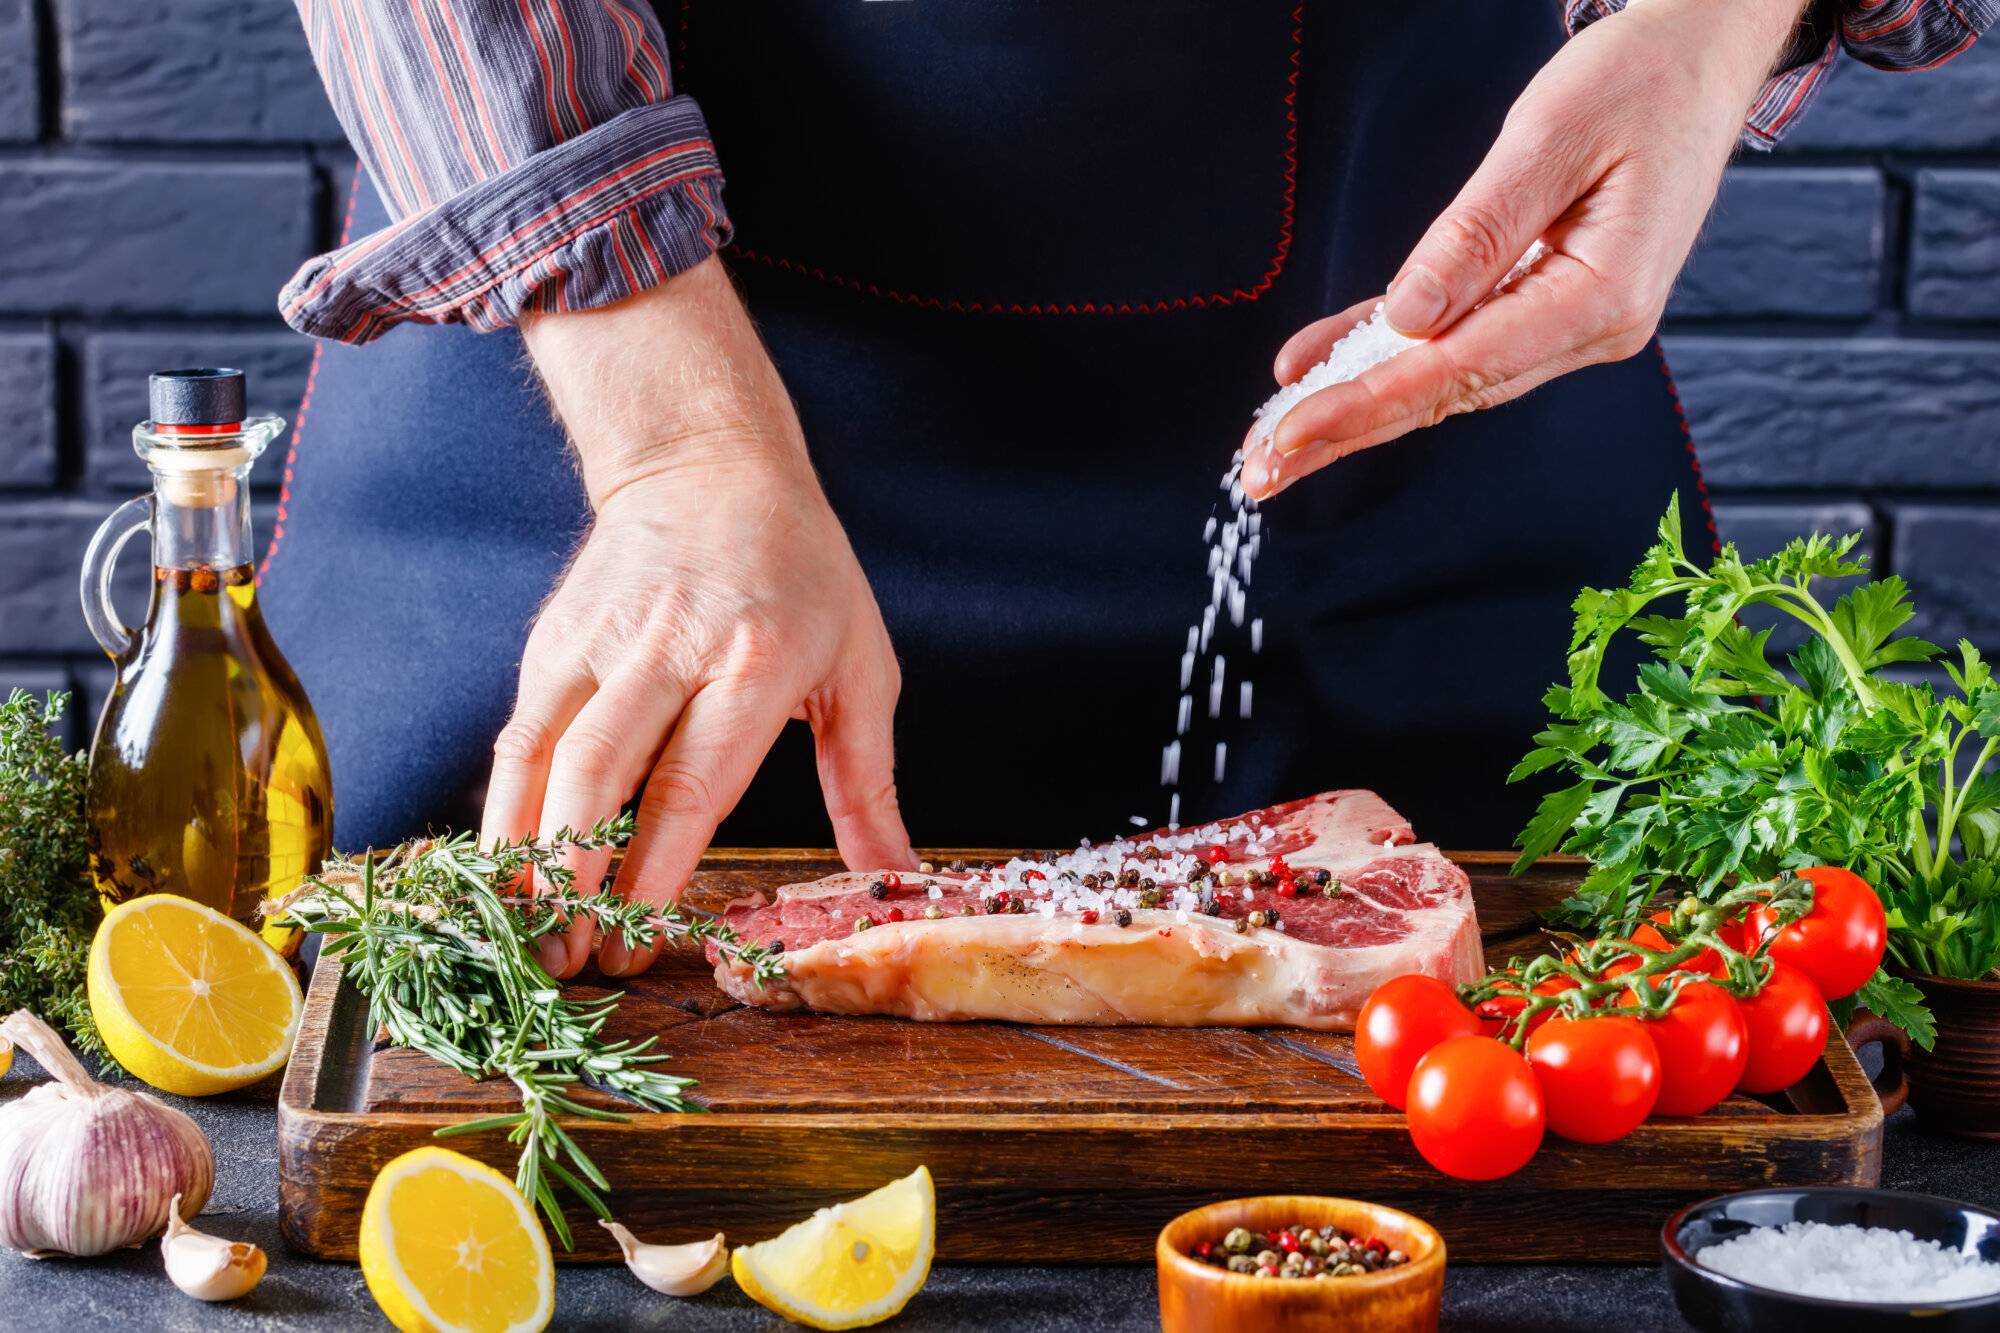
top-left (1510, 492), bottom-right (2000, 1049)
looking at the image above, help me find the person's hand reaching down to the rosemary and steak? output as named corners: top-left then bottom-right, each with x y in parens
top-left (480, 260), bottom-right (914, 977)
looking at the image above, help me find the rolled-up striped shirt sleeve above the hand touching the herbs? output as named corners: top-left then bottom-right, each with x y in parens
top-left (278, 0), bottom-right (730, 342)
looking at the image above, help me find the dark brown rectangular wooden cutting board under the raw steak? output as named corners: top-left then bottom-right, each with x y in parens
top-left (278, 851), bottom-right (1882, 1263)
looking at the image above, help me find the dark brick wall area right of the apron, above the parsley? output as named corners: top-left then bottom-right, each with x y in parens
top-left (1666, 38), bottom-right (2000, 668)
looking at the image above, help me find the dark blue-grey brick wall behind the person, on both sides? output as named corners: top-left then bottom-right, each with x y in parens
top-left (0, 0), bottom-right (2000, 735)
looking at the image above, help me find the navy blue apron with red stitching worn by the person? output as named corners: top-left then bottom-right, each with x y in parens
top-left (266, 0), bottom-right (1704, 847)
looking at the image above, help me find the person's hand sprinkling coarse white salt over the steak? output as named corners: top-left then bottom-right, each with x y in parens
top-left (1244, 0), bottom-right (1802, 500)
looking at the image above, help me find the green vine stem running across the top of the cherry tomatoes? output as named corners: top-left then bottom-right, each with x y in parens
top-left (1458, 875), bottom-right (1812, 1051)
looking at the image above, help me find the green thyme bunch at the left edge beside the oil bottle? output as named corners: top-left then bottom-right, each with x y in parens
top-left (0, 691), bottom-right (108, 1059)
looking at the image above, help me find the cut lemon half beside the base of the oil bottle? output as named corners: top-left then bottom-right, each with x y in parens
top-left (88, 893), bottom-right (302, 1097)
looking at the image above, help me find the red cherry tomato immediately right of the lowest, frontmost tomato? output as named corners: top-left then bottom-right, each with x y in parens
top-left (1528, 1015), bottom-right (1660, 1143)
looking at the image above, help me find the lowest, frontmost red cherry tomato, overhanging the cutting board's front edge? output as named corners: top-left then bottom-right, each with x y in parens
top-left (1408, 1037), bottom-right (1544, 1181)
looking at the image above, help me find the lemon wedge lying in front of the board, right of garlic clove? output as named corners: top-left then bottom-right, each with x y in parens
top-left (730, 1167), bottom-right (938, 1329)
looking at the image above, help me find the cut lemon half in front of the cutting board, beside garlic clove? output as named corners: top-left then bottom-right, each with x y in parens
top-left (360, 1147), bottom-right (556, 1333)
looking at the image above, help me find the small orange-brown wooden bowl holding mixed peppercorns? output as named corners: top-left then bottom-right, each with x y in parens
top-left (1154, 1195), bottom-right (1444, 1333)
